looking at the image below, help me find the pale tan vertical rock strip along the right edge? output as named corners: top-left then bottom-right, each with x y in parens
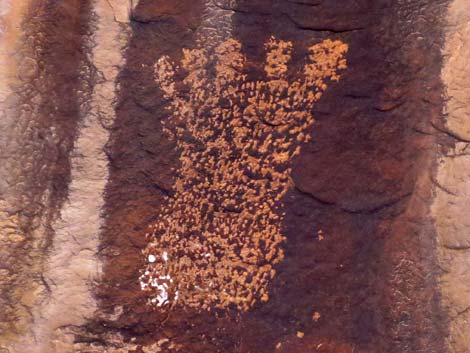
top-left (432, 0), bottom-right (470, 353)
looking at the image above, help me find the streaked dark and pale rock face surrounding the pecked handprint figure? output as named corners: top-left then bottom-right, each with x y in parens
top-left (0, 0), bottom-right (470, 353)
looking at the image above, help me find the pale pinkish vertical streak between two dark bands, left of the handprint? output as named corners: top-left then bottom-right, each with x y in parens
top-left (5, 0), bottom-right (125, 353)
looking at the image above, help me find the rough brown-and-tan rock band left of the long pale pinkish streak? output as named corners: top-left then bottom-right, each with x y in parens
top-left (0, 1), bottom-right (94, 339)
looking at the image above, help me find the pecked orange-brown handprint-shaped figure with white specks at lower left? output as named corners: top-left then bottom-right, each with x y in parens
top-left (140, 38), bottom-right (348, 310)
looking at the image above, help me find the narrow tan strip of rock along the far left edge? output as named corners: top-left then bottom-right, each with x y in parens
top-left (0, 0), bottom-right (34, 344)
